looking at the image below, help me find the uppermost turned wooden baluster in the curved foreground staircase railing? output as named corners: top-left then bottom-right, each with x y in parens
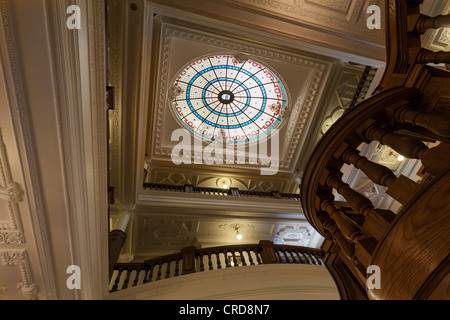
top-left (394, 106), bottom-right (450, 138)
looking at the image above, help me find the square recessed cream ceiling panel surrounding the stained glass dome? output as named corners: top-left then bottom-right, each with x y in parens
top-left (150, 18), bottom-right (335, 172)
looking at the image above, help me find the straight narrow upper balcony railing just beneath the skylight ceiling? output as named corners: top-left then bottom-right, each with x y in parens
top-left (144, 183), bottom-right (300, 201)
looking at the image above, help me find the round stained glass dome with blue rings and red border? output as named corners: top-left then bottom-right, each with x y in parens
top-left (172, 55), bottom-right (287, 143)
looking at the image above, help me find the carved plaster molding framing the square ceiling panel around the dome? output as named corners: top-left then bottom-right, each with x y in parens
top-left (153, 25), bottom-right (329, 169)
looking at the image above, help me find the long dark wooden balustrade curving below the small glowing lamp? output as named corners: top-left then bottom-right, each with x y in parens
top-left (110, 241), bottom-right (324, 292)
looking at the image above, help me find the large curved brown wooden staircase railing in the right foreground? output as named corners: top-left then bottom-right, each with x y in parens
top-left (301, 0), bottom-right (450, 299)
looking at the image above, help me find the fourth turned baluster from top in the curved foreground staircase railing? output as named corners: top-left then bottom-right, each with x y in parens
top-left (326, 171), bottom-right (395, 240)
